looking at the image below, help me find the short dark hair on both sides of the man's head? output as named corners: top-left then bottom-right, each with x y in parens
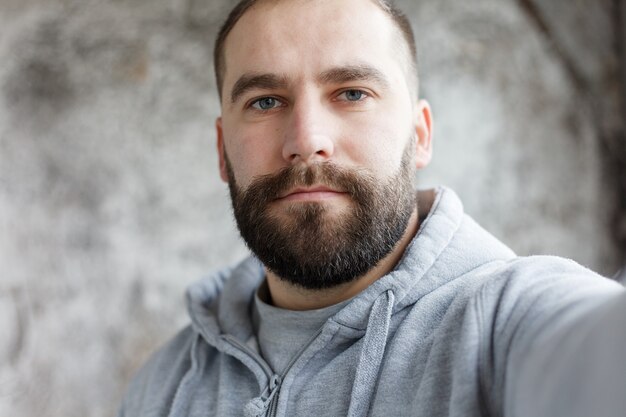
top-left (213, 0), bottom-right (417, 99)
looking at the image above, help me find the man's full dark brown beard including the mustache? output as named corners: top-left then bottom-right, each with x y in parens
top-left (225, 140), bottom-right (417, 290)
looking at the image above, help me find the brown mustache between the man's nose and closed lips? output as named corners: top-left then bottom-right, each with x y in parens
top-left (240, 162), bottom-right (375, 203)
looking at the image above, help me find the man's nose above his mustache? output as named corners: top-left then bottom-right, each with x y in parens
top-left (283, 98), bottom-right (335, 165)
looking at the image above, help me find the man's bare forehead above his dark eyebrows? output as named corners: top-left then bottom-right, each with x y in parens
top-left (219, 0), bottom-right (403, 91)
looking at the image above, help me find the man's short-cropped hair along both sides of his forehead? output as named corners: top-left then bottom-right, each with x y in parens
top-left (213, 0), bottom-right (418, 102)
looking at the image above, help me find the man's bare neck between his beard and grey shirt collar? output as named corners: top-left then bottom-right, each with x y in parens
top-left (265, 210), bottom-right (419, 310)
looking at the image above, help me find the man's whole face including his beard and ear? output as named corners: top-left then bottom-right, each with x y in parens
top-left (217, 0), bottom-right (430, 288)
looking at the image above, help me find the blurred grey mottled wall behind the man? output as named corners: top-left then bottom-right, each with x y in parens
top-left (0, 0), bottom-right (626, 417)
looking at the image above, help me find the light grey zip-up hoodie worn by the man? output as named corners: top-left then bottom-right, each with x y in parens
top-left (119, 188), bottom-right (626, 417)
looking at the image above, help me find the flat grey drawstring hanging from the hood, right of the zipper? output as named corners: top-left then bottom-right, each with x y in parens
top-left (348, 290), bottom-right (395, 417)
